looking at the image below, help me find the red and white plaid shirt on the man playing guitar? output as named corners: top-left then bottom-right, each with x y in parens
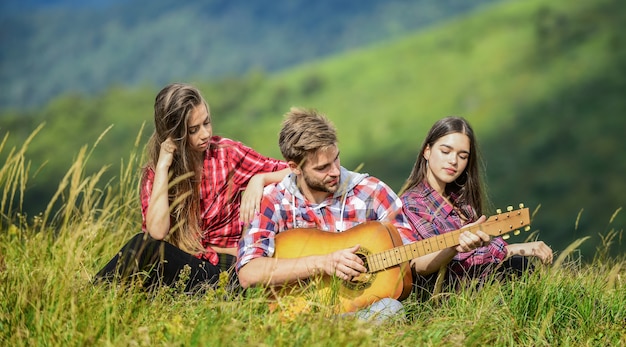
top-left (236, 168), bottom-right (416, 271)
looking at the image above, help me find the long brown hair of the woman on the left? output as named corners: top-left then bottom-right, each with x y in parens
top-left (147, 83), bottom-right (210, 254)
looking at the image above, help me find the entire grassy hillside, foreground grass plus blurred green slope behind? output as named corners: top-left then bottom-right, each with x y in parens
top-left (0, 0), bottom-right (626, 346)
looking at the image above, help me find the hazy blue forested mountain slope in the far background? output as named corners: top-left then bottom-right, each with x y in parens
top-left (0, 0), bottom-right (496, 108)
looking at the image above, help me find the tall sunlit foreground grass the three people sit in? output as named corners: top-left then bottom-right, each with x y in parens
top-left (0, 123), bottom-right (626, 346)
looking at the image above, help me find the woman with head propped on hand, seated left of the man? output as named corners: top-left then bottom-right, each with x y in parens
top-left (95, 83), bottom-right (289, 291)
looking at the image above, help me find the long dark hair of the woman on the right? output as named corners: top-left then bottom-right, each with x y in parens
top-left (399, 117), bottom-right (484, 217)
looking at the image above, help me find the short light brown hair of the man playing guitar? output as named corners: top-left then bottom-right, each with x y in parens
top-left (278, 107), bottom-right (337, 165)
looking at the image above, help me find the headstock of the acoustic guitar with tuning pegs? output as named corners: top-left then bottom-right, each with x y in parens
top-left (479, 204), bottom-right (530, 239)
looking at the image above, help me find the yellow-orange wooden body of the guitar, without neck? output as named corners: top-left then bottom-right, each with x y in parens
top-left (274, 221), bottom-right (412, 312)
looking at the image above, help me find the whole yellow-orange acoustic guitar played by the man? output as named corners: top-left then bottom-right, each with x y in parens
top-left (271, 204), bottom-right (530, 313)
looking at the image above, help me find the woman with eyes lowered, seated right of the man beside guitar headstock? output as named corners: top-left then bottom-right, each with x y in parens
top-left (400, 117), bottom-right (552, 294)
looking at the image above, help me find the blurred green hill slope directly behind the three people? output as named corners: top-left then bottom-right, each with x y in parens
top-left (1, 0), bottom-right (626, 260)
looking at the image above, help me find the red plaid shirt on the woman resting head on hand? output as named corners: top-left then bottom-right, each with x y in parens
top-left (141, 136), bottom-right (287, 265)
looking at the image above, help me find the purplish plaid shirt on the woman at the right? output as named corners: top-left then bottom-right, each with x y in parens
top-left (401, 181), bottom-right (507, 276)
